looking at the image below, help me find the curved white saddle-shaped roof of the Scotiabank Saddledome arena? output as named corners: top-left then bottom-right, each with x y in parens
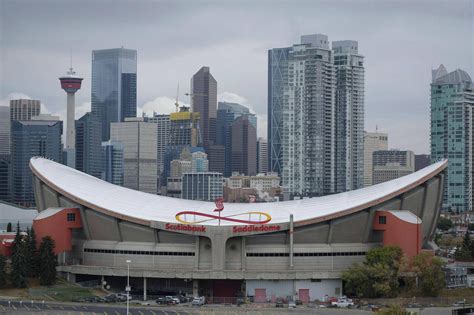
top-left (30, 157), bottom-right (447, 225)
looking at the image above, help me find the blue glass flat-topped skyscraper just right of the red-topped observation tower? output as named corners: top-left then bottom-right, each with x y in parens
top-left (91, 48), bottom-right (137, 141)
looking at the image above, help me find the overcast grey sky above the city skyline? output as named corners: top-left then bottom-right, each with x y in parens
top-left (0, 0), bottom-right (474, 153)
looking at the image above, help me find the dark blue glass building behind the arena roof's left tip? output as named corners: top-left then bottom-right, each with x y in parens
top-left (11, 120), bottom-right (63, 207)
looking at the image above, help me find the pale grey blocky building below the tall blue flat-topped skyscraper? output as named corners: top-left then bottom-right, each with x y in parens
top-left (110, 117), bottom-right (158, 194)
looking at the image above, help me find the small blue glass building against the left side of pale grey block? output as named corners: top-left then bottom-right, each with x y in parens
top-left (102, 140), bottom-right (124, 186)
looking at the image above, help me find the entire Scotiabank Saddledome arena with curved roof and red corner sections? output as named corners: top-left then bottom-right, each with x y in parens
top-left (30, 157), bottom-right (447, 302)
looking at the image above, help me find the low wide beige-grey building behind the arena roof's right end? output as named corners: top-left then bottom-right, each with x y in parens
top-left (372, 150), bottom-right (415, 185)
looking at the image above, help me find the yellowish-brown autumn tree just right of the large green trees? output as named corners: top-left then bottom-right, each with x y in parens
top-left (411, 253), bottom-right (446, 296)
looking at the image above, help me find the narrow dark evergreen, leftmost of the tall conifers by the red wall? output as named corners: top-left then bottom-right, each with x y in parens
top-left (10, 222), bottom-right (27, 288)
